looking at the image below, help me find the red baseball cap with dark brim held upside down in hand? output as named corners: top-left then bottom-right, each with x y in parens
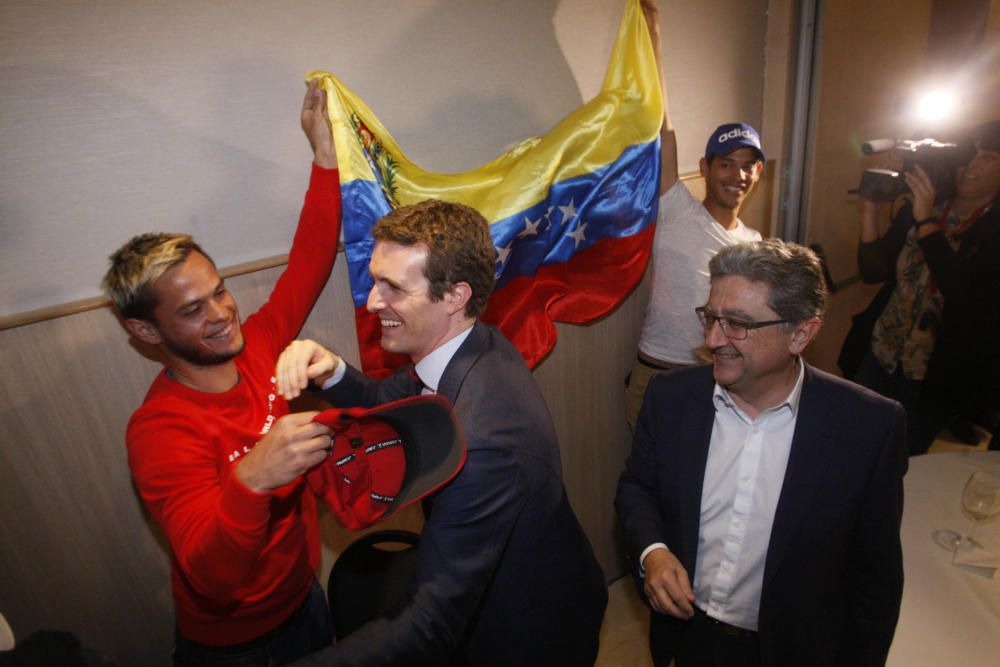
top-left (306, 394), bottom-right (466, 530)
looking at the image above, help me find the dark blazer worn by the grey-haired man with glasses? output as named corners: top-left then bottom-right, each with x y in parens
top-left (615, 365), bottom-right (907, 667)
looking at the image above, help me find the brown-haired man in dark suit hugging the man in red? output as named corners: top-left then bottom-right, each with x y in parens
top-left (278, 201), bottom-right (607, 667)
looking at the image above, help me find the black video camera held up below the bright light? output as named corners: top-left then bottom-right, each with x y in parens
top-left (851, 138), bottom-right (975, 204)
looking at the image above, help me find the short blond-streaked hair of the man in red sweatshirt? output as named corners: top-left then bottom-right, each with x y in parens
top-left (101, 232), bottom-right (214, 321)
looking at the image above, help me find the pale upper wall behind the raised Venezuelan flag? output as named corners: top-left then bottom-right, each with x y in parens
top-left (0, 0), bottom-right (766, 317)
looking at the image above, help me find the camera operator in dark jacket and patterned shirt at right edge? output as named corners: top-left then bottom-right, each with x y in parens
top-left (838, 121), bottom-right (1000, 455)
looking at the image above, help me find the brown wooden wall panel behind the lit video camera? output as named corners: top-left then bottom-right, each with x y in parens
top-left (803, 0), bottom-right (932, 282)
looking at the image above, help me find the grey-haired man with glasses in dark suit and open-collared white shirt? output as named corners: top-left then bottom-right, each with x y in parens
top-left (615, 240), bottom-right (906, 667)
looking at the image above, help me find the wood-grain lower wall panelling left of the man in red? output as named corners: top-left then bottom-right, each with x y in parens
top-left (0, 310), bottom-right (171, 664)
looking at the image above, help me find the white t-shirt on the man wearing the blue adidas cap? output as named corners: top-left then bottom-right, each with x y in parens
top-left (639, 180), bottom-right (761, 364)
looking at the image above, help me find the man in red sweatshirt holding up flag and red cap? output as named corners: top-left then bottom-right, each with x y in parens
top-left (104, 80), bottom-right (340, 666)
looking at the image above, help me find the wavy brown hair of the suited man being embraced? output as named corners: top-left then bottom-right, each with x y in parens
top-left (372, 199), bottom-right (496, 317)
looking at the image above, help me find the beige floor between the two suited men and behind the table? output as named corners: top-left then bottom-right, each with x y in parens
top-left (595, 431), bottom-right (989, 667)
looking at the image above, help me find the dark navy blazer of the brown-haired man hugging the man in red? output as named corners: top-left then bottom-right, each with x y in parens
top-left (295, 322), bottom-right (607, 667)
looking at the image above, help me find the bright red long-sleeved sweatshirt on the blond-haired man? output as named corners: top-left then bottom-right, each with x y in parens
top-left (126, 164), bottom-right (340, 646)
